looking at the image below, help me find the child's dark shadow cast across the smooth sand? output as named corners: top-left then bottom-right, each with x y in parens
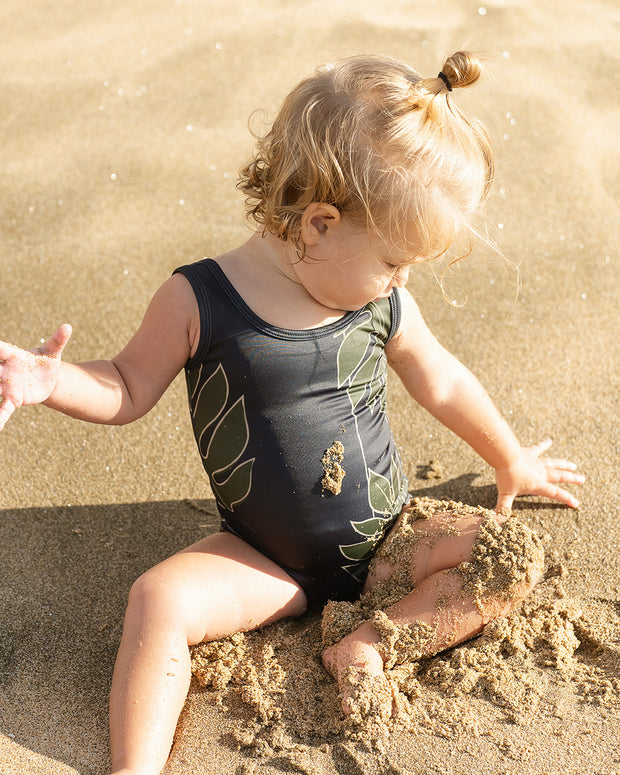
top-left (0, 474), bottom-right (561, 775)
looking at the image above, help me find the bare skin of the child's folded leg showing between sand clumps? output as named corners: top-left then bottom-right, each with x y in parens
top-left (323, 514), bottom-right (543, 712)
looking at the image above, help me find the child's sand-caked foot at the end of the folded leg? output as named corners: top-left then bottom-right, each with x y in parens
top-left (323, 622), bottom-right (394, 723)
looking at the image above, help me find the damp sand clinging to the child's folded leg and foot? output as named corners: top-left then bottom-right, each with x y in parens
top-left (323, 499), bottom-right (544, 730)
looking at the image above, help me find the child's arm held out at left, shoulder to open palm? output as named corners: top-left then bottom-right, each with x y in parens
top-left (0, 275), bottom-right (199, 430)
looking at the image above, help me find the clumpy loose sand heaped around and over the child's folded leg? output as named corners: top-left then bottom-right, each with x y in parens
top-left (192, 499), bottom-right (620, 773)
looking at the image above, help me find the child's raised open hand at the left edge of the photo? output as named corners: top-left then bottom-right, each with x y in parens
top-left (0, 323), bottom-right (71, 431)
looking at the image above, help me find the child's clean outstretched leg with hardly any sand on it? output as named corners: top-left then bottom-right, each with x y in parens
top-left (110, 533), bottom-right (306, 775)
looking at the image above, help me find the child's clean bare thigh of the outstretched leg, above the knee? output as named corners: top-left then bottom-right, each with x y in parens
top-left (130, 533), bottom-right (307, 644)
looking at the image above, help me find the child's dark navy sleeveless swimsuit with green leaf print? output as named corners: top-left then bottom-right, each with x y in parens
top-left (175, 259), bottom-right (407, 603)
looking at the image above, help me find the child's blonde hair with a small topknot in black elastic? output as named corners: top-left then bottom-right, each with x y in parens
top-left (238, 51), bottom-right (493, 260)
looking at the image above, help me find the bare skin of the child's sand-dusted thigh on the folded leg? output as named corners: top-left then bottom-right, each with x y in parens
top-left (365, 512), bottom-right (505, 589)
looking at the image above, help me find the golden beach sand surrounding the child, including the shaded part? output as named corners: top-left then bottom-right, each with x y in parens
top-left (0, 0), bottom-right (620, 775)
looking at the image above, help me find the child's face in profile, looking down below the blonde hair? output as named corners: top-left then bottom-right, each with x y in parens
top-left (295, 218), bottom-right (416, 311)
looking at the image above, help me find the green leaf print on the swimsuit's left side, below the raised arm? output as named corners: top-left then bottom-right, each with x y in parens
top-left (188, 363), bottom-right (255, 511)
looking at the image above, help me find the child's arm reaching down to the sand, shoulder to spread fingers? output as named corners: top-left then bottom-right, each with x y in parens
top-left (386, 289), bottom-right (584, 510)
